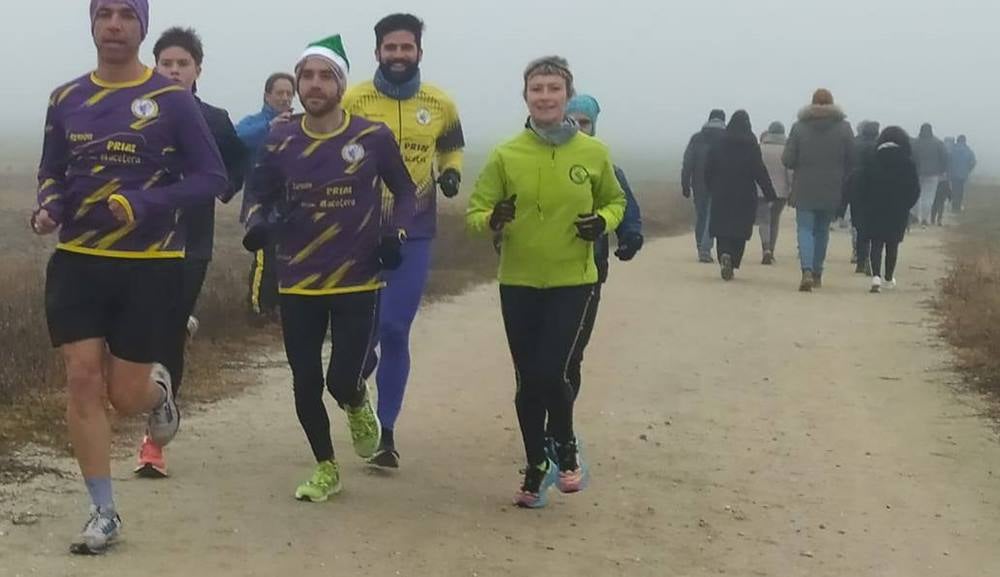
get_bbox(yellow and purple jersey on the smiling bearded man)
[343,80,465,239]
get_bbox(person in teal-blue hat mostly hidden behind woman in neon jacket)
[566,94,643,393]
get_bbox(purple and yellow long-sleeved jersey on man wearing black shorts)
[38,69,227,259]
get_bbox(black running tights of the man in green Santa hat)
[281,291,379,462]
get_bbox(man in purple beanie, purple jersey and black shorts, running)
[31,0,226,554]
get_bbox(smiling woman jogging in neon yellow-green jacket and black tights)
[466,56,625,508]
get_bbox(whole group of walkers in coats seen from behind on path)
[681,89,976,292]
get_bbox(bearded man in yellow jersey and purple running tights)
[344,14,465,468]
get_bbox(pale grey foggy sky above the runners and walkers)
[0,0,1000,177]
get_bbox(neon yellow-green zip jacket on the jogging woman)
[466,129,625,288]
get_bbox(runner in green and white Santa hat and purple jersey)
[244,36,416,502]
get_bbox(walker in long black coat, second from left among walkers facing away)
[705,110,778,280]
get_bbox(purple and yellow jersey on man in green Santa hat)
[247,113,416,296]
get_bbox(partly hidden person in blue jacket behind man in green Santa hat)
[236,72,295,318]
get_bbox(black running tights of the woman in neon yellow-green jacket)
[500,285,598,466]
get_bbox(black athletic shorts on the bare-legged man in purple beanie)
[45,250,184,363]
